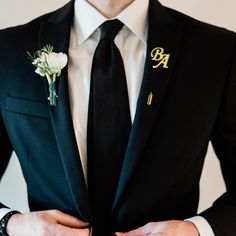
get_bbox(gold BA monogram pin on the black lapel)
[151,47,170,69]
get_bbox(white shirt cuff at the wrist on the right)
[185,216,215,236]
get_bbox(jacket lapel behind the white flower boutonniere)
[39,1,91,222]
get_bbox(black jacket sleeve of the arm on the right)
[200,35,236,236]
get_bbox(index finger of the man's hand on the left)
[48,210,88,229]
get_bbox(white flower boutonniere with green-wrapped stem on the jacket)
[27,44,68,106]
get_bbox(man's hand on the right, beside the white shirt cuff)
[116,220,199,236]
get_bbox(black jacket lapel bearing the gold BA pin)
[113,0,182,209]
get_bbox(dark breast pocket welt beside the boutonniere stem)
[6,95,50,118]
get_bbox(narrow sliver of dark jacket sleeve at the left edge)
[0,107,13,208]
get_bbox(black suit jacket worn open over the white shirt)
[0,0,236,236]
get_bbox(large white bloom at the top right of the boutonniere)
[45,52,68,70]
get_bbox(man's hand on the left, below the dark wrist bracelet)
[7,210,89,236]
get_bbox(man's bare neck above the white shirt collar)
[86,0,134,18]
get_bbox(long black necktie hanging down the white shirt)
[88,20,131,236]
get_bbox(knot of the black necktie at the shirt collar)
[100,20,123,40]
